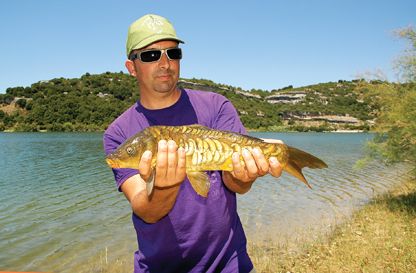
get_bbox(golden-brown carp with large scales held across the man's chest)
[106,124,328,197]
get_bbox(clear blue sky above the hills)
[0,0,416,93]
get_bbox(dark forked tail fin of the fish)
[283,146,328,188]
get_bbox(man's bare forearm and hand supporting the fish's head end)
[121,140,186,223]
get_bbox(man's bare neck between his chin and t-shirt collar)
[140,88,181,110]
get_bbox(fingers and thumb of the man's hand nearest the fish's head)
[139,140,186,189]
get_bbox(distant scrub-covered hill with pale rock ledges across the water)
[0,72,384,131]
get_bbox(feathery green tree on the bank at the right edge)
[364,28,416,175]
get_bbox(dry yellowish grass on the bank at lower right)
[248,176,416,273]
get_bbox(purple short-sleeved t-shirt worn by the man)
[104,89,253,272]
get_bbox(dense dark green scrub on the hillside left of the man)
[0,72,138,131]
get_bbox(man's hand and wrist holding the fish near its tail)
[223,139,283,193]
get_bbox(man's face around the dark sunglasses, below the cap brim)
[126,41,180,93]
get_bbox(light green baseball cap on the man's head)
[126,14,183,58]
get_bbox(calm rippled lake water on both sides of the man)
[0,133,405,272]
